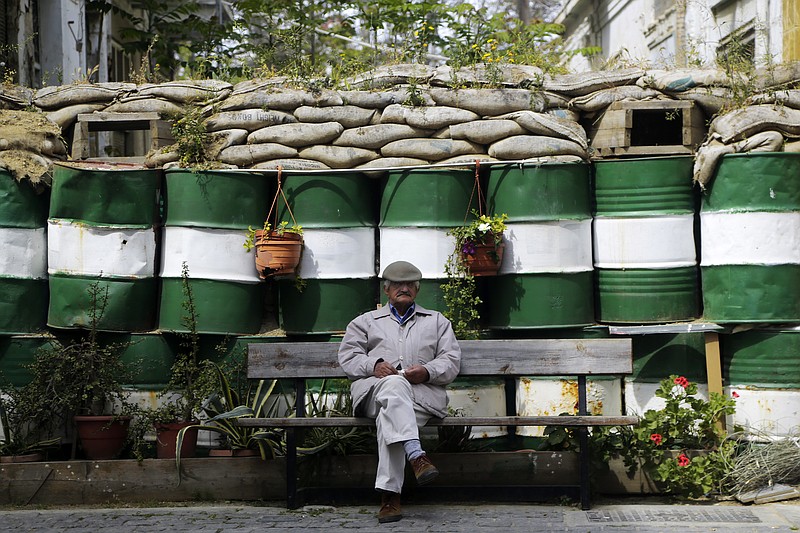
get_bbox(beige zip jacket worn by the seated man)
[339,304,461,417]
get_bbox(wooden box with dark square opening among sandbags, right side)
[588,100,707,157]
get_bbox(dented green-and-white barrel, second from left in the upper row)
[47,163,160,331]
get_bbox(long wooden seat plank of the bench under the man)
[236,415,638,428]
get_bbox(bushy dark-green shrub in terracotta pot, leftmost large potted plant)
[15,282,138,459]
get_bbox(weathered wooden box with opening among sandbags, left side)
[72,112,175,162]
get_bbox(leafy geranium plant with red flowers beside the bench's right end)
[544,375,736,498]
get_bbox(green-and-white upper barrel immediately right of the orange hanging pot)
[277,172,378,335]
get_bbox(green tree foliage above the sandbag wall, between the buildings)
[94,0,592,80]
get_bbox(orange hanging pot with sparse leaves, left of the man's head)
[244,220,303,279]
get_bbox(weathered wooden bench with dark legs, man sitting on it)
[237,338,638,509]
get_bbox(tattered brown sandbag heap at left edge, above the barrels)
[0,110,66,184]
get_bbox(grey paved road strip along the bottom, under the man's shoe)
[0,503,800,533]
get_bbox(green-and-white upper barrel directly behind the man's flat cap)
[378,169,478,311]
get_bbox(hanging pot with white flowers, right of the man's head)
[448,210,508,276]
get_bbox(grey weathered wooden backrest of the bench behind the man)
[247,338,633,379]
